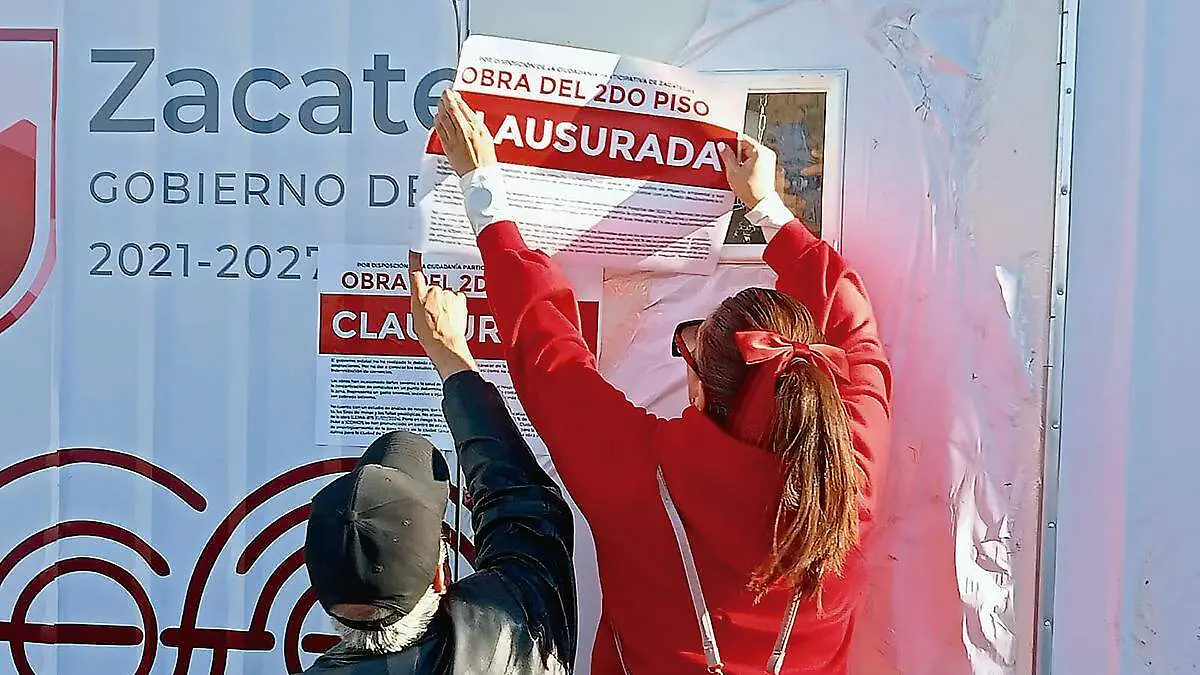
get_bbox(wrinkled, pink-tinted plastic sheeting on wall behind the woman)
[602,0,1050,675]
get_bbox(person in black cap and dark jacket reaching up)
[305,258,577,675]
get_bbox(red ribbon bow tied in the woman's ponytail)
[730,330,850,447]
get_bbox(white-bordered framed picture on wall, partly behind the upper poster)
[709,70,846,263]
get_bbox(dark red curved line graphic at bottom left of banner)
[0,448,475,675]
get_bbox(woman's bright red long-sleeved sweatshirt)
[479,220,892,675]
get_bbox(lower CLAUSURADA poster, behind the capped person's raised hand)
[316,246,600,449]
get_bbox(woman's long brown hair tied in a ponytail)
[696,288,858,602]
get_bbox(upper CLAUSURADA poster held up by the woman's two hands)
[419,36,744,273]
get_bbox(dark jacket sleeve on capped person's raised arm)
[442,371,578,663]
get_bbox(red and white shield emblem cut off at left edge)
[0,29,58,333]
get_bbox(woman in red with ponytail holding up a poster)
[437,91,892,675]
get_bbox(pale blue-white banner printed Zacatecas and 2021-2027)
[0,0,473,675]
